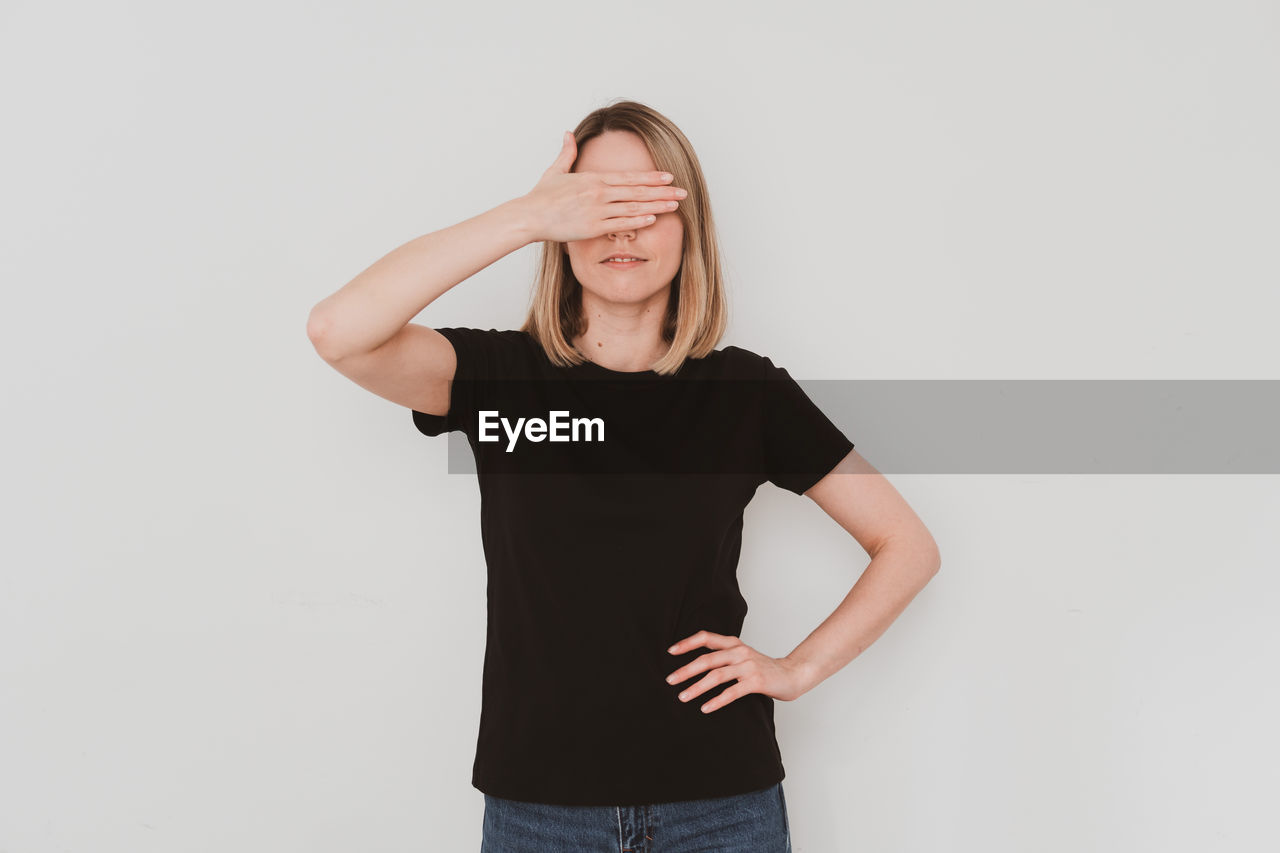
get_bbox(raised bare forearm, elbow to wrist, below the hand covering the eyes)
[307,197,532,359]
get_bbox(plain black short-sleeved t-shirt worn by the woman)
[412,328,854,806]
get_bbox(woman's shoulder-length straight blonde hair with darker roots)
[521,100,728,375]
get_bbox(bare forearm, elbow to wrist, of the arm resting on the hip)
[787,539,940,693]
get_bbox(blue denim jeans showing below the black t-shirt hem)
[480,783,791,853]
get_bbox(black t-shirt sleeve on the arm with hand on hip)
[762,357,854,494]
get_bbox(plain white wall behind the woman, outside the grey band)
[0,0,1280,853]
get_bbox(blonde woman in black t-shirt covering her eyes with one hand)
[308,101,940,853]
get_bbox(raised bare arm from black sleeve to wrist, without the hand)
[307,196,535,415]
